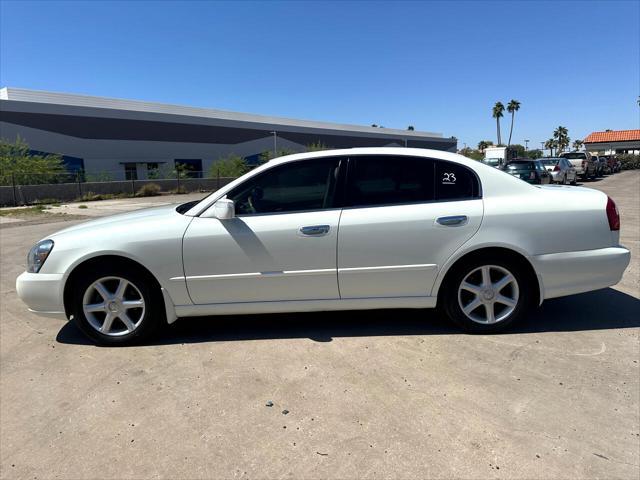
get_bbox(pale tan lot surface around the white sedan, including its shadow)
[0,172,640,479]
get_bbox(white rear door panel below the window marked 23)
[338,200,482,298]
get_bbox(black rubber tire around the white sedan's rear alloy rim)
[441,254,535,333]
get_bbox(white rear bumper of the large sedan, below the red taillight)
[532,247,631,300]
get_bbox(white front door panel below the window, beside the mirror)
[182,210,340,304]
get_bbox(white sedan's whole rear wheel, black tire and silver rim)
[443,256,532,333]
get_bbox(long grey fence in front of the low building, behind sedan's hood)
[0,170,235,206]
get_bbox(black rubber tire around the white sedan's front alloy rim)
[70,265,166,346]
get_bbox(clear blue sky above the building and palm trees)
[0,0,640,148]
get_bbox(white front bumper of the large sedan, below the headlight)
[16,272,67,319]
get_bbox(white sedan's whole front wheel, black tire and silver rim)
[71,267,164,345]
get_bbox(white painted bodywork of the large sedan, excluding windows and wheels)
[16,148,629,321]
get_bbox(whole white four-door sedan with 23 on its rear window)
[17,148,629,344]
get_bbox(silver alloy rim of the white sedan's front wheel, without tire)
[82,277,145,337]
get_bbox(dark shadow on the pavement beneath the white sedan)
[56,288,640,346]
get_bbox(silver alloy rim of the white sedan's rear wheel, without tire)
[458,265,520,324]
